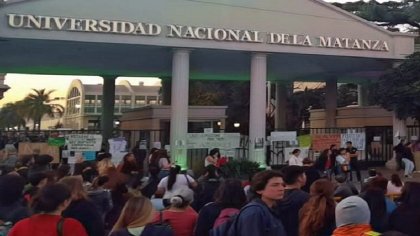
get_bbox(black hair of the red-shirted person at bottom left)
[31,184,71,213]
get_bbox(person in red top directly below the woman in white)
[154,187,198,236]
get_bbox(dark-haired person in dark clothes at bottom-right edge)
[389,182,420,236]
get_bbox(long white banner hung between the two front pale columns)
[187,133,241,149]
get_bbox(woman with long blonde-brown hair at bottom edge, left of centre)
[110,196,172,236]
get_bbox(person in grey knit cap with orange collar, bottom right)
[332,196,379,236]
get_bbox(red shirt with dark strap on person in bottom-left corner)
[8,214,87,236]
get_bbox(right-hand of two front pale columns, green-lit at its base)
[249,53,267,168]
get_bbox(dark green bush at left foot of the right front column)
[221,159,260,179]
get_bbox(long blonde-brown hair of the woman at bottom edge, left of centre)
[111,196,155,232]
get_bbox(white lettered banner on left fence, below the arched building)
[66,134,102,152]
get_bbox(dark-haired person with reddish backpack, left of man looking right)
[194,179,246,236]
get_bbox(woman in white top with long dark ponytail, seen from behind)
[156,165,197,207]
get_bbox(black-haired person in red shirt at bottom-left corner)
[8,184,88,236]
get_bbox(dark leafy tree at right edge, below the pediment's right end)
[374,52,420,121]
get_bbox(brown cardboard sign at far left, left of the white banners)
[18,143,60,163]
